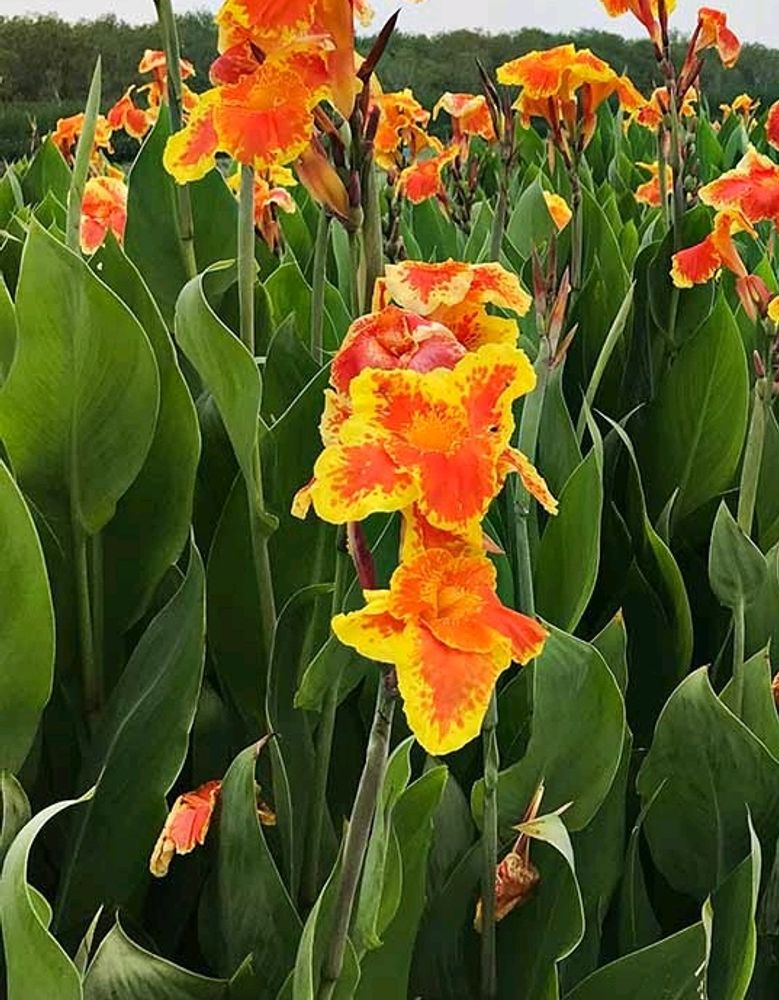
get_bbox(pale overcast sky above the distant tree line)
[0,0,779,47]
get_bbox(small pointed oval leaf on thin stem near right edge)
[709,500,768,611]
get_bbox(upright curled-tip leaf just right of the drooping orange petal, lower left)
[200,737,302,993]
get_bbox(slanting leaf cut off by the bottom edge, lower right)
[565,924,706,1000]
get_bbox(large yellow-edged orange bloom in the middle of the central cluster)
[293,344,548,538]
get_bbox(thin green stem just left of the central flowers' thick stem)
[302,544,349,907]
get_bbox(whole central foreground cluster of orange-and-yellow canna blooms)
[293,261,556,753]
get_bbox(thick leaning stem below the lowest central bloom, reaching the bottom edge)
[318,677,395,1000]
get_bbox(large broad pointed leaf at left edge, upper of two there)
[0,223,159,534]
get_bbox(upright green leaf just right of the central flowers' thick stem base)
[355,766,448,1000]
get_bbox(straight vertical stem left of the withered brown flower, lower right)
[481,691,500,1000]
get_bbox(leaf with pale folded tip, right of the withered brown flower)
[498,815,584,1000]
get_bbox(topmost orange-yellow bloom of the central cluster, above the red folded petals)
[386,260,532,351]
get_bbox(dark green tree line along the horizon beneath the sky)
[0,12,779,159]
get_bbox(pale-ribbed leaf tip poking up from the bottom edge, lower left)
[84,921,232,1000]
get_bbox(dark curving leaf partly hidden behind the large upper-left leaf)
[92,239,200,630]
